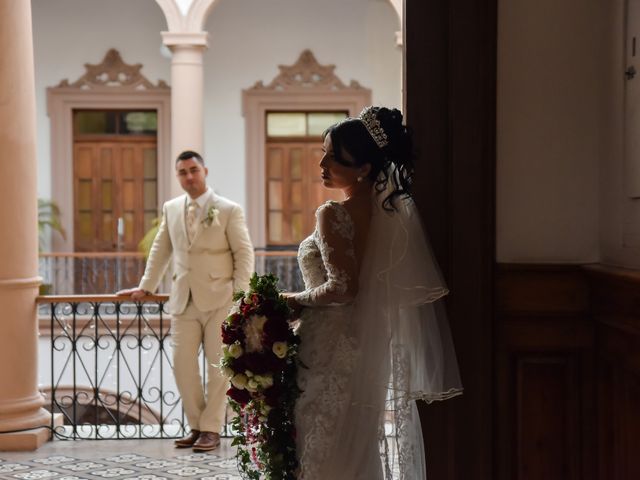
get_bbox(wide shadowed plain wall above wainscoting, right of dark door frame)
[496,0,609,263]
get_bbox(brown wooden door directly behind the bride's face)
[266,141,343,246]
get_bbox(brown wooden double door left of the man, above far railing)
[74,139,157,252]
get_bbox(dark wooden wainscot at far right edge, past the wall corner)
[586,265,640,480]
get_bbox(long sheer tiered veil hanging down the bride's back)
[322,171,462,480]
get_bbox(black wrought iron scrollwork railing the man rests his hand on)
[38,295,196,439]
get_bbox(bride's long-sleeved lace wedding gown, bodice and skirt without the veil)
[296,202,358,480]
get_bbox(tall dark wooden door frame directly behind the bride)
[403,0,500,480]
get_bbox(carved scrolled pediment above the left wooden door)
[57,48,169,90]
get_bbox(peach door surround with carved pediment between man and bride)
[242,50,371,248]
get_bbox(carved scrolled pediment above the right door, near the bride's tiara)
[251,50,364,91]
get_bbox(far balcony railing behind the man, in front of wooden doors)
[39,250,303,295]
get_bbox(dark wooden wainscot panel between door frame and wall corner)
[495,265,596,480]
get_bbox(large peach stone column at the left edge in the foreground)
[0,0,51,450]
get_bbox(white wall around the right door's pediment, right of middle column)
[204,0,402,204]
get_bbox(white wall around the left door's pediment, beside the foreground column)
[31,0,171,202]
